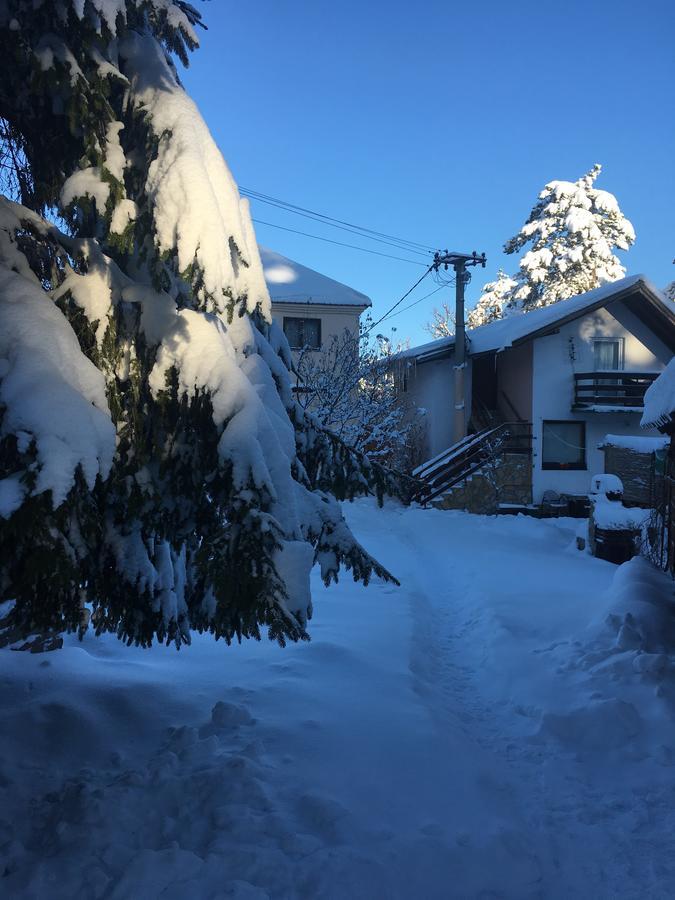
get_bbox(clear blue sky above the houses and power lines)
[183,0,675,343]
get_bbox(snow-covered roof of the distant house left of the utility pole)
[258,247,372,309]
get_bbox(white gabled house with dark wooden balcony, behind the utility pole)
[401,275,675,503]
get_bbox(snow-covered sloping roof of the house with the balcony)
[401,275,675,363]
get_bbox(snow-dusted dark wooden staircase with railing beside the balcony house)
[413,422,532,506]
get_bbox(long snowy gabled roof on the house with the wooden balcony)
[401,275,675,362]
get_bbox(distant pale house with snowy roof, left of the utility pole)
[259,247,371,358]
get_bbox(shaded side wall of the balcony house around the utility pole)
[403,356,471,459]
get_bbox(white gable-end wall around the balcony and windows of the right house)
[532,304,671,503]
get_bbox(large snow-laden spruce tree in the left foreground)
[0,0,402,645]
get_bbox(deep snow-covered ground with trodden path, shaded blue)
[0,501,675,900]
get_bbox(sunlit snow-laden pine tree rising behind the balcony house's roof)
[504,164,635,311]
